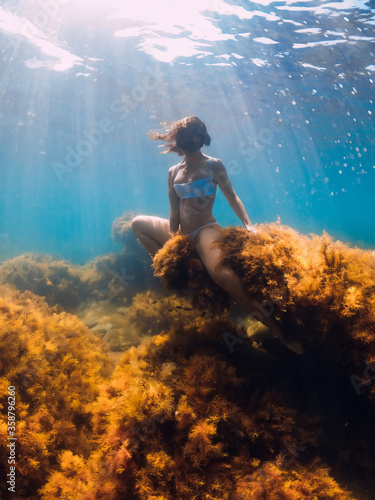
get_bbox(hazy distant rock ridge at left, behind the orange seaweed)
[0,252,157,313]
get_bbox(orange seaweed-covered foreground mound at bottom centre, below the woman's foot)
[40,319,356,500]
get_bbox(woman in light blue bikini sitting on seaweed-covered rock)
[132,116,298,350]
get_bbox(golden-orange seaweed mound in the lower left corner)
[0,287,112,498]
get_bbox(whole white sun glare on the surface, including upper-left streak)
[0,0,247,68]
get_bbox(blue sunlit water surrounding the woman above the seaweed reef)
[0,0,375,262]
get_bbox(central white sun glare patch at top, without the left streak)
[62,0,241,63]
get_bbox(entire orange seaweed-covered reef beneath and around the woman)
[0,225,375,500]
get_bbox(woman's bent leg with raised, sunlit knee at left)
[132,215,171,257]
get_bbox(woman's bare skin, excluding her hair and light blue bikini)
[132,150,301,353]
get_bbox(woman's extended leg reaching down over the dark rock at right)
[197,227,302,354]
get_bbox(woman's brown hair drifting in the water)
[148,116,211,156]
